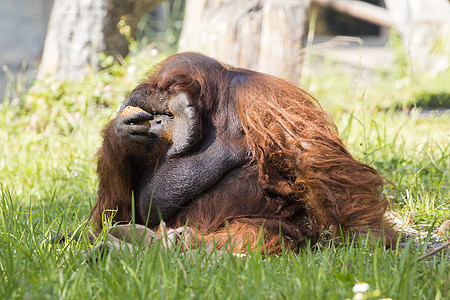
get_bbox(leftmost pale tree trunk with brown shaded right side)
[38,0,162,80]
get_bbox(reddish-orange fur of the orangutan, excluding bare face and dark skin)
[93,54,392,253]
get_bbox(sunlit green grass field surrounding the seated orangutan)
[0,49,450,299]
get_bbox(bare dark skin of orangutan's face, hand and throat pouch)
[112,91,250,227]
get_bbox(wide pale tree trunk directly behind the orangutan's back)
[178,0,310,83]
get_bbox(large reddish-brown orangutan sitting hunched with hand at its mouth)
[91,53,387,251]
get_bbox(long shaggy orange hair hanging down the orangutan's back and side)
[236,72,388,236]
